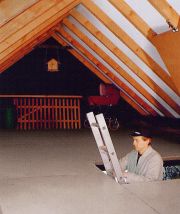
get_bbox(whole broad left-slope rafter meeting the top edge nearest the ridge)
[0,0,79,72]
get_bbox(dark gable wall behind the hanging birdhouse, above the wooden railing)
[0,39,101,96]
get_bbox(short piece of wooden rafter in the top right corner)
[148,0,179,28]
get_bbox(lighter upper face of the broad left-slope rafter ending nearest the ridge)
[0,0,79,53]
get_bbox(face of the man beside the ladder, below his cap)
[133,136,150,154]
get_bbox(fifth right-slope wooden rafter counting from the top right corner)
[63,18,173,117]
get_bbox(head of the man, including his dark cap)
[131,130,152,154]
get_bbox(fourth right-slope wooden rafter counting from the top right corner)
[70,9,180,113]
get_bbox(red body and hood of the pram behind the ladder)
[88,83,120,105]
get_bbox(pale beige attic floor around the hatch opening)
[0,129,180,214]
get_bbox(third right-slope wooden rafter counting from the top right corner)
[82,0,177,92]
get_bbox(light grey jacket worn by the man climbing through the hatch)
[120,146,163,183]
